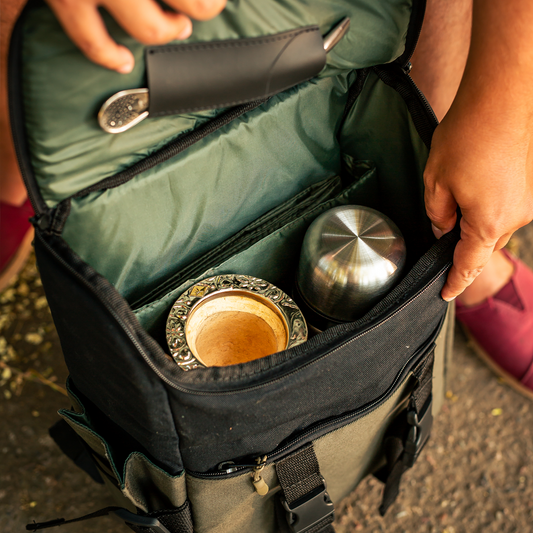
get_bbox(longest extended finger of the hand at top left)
[48,0,134,74]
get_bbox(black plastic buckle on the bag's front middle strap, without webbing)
[281,478,335,533]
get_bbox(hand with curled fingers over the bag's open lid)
[46,0,226,74]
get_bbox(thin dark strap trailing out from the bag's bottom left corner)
[26,500,193,533]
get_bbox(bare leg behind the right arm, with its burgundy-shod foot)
[411,0,533,399]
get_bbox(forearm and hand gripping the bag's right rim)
[424,0,533,300]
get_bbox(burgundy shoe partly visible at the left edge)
[0,199,33,292]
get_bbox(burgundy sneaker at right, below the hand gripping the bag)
[457,250,533,400]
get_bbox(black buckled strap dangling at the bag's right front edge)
[377,348,435,516]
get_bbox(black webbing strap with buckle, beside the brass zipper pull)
[276,444,335,533]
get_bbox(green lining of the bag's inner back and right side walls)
[60,67,431,324]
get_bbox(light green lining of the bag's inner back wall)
[63,75,354,302]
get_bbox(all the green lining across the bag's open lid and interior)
[19,0,432,354]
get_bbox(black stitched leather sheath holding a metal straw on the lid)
[146,26,326,116]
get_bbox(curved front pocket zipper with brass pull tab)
[190,317,438,480]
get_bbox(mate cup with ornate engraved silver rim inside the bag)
[166,274,307,370]
